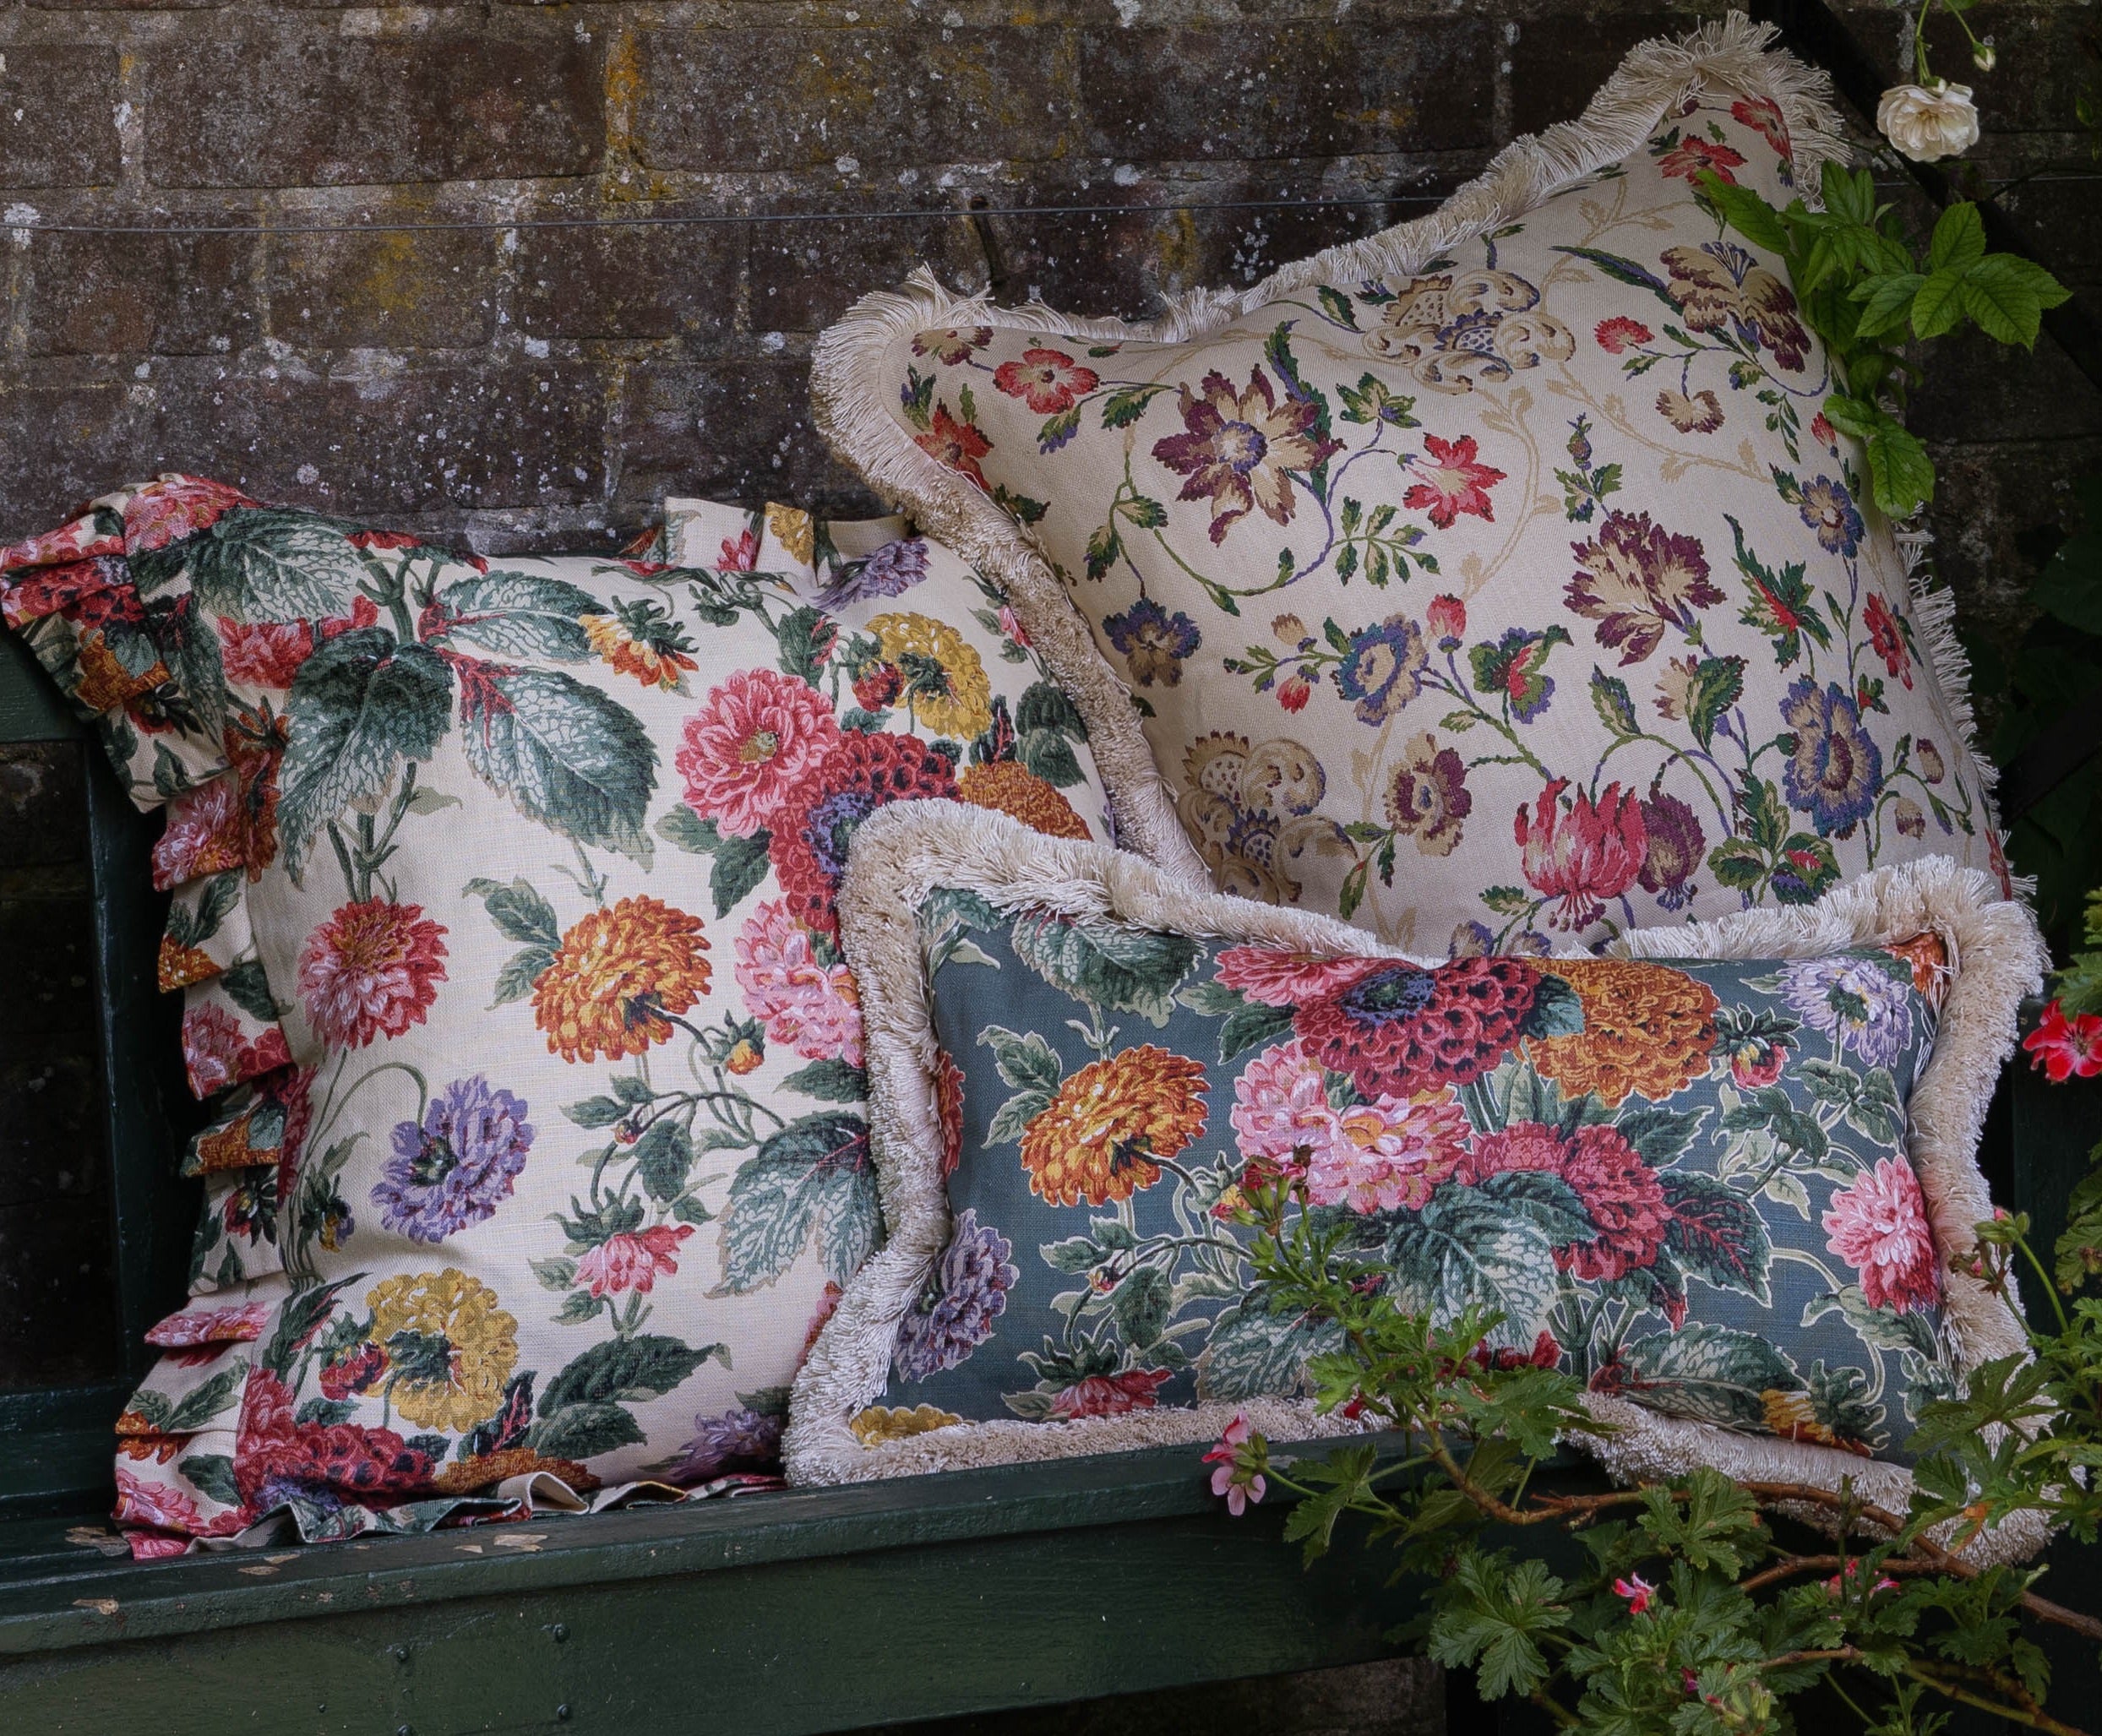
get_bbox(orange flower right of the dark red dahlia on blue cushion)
[1526,958,1718,1106]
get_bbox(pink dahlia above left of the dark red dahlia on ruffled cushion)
[677,668,839,839]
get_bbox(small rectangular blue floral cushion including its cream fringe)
[788,803,2039,1547]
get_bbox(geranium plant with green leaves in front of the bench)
[1206,1167,2102,1736]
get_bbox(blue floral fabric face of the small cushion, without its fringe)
[882,895,1952,1452]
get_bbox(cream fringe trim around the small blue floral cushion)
[784,801,2045,1562]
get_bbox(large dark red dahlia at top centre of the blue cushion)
[1293,958,1538,1097]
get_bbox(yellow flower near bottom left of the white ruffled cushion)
[366,1265,520,1434]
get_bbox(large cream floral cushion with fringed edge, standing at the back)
[818,19,2006,952]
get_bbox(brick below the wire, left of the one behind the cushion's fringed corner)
[520,223,746,339]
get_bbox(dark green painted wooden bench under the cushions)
[0,634,2102,1736]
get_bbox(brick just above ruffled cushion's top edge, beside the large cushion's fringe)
[618,357,876,513]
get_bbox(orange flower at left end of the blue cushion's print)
[1021,1044,1206,1206]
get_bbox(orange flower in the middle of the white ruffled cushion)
[531,897,711,1061]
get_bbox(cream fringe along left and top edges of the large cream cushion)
[811,13,1845,884]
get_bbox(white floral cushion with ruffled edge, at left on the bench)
[0,475,1135,1554]
